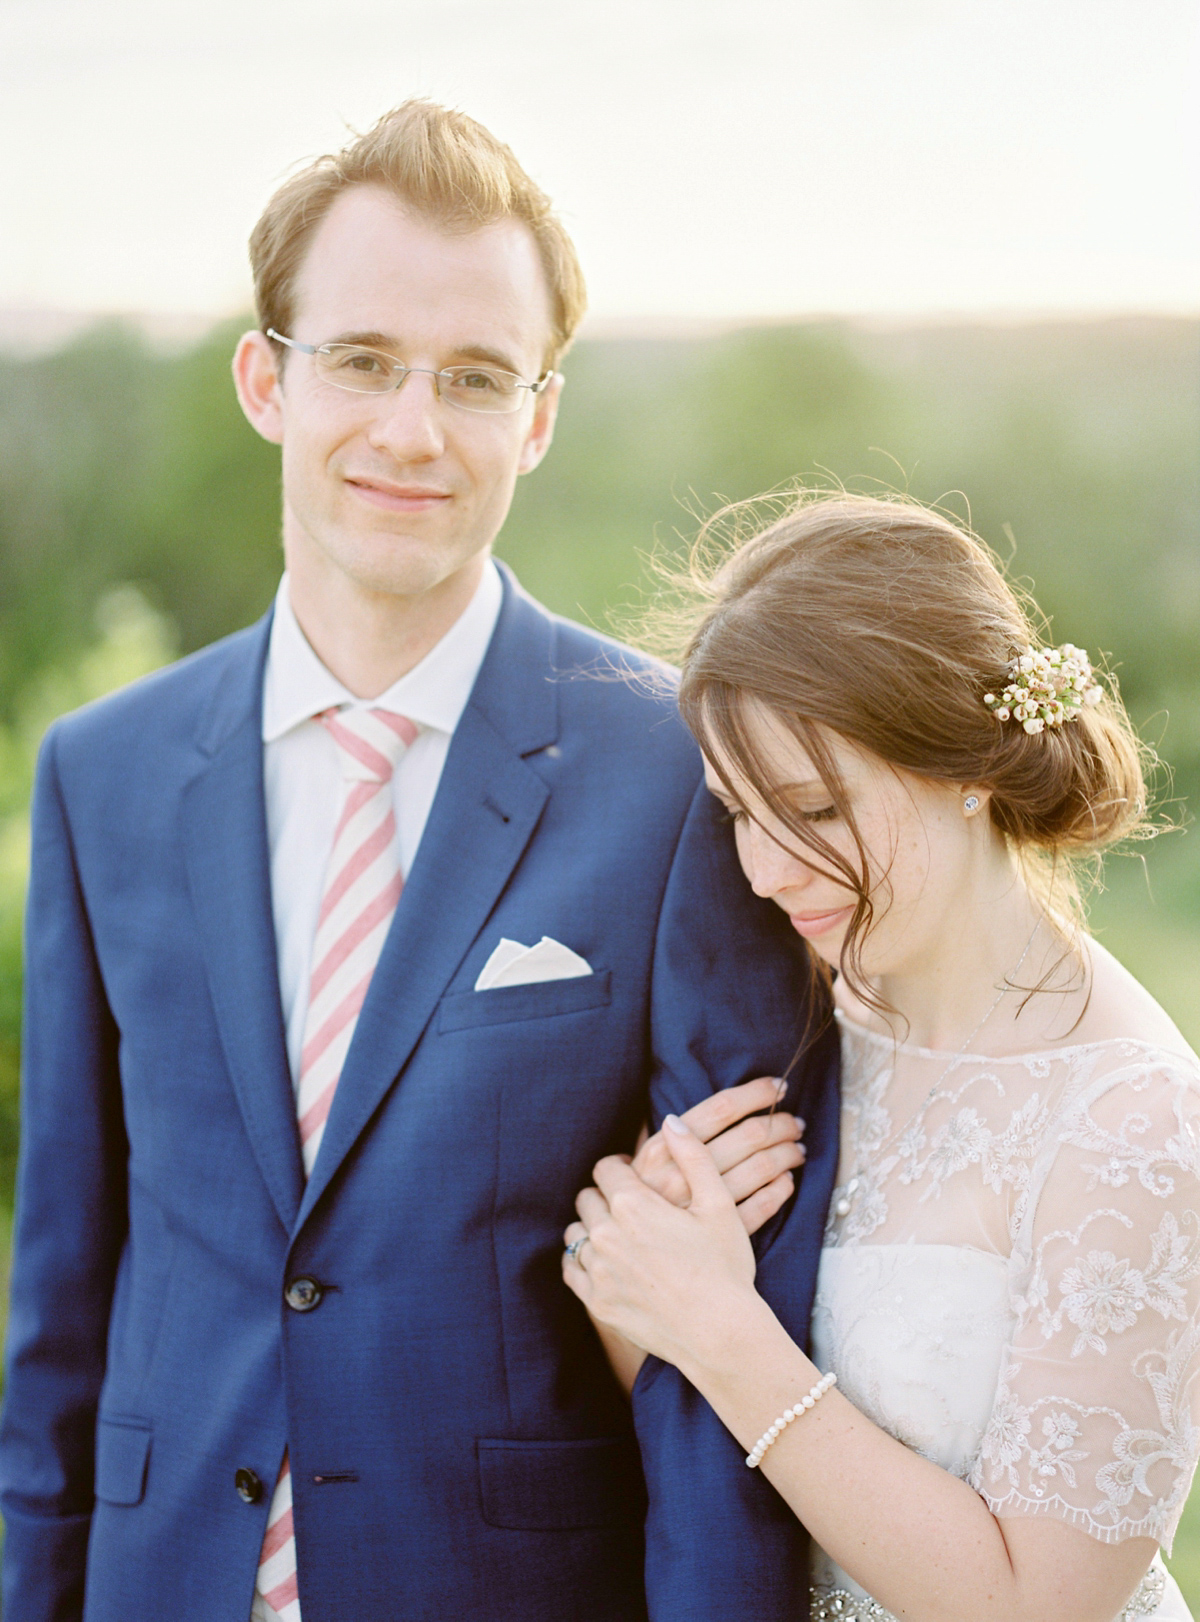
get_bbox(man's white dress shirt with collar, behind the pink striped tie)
[263,561,503,1080]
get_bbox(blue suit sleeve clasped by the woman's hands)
[632,772,838,1622]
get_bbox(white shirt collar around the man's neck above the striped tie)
[263,560,504,743]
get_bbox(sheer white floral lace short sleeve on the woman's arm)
[971,1051,1200,1552]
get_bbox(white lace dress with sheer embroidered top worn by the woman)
[812,1017,1200,1622]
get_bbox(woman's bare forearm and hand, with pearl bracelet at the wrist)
[564,1122,1156,1622]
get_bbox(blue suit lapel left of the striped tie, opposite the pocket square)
[183,618,303,1233]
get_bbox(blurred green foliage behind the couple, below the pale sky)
[0,320,1200,1590]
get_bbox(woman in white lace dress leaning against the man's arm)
[563,495,1200,1622]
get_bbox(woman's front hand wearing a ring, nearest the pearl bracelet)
[563,1115,758,1371]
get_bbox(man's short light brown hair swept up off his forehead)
[250,99,587,367]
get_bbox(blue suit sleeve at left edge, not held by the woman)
[0,728,128,1622]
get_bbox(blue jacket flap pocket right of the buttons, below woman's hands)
[477,1437,645,1531]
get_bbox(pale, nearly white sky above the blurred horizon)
[0,0,1200,323]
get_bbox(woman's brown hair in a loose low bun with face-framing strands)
[649,490,1148,1002]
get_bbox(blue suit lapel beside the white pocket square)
[300,571,558,1221]
